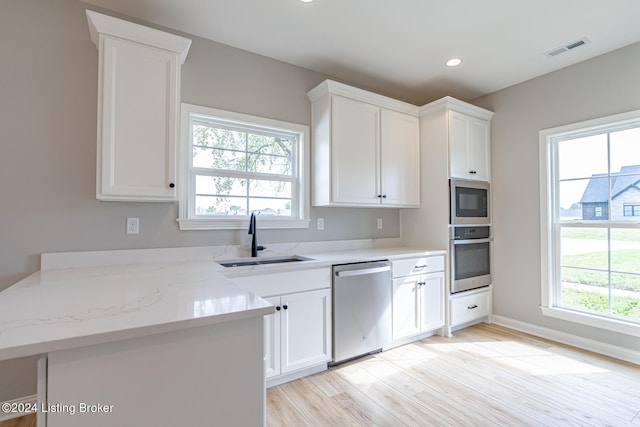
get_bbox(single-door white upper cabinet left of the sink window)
[87,10,191,202]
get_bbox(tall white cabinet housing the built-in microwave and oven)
[400,97,493,334]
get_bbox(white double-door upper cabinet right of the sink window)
[308,80,420,207]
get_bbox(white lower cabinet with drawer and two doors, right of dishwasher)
[392,256,445,343]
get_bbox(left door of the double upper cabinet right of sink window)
[331,95,380,205]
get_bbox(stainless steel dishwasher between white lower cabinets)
[331,260,391,364]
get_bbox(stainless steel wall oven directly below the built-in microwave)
[450,226,492,294]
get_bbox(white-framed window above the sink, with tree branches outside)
[178,104,309,230]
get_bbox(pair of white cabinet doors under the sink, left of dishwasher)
[264,289,331,379]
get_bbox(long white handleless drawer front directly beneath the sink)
[229,268,331,297]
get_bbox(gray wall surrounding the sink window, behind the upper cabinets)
[0,0,400,401]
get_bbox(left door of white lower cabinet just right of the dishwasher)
[392,276,422,340]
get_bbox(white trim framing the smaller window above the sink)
[177,102,310,230]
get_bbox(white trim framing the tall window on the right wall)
[538,110,640,337]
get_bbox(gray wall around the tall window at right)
[473,43,640,351]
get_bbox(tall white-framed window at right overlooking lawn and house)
[540,111,640,336]
